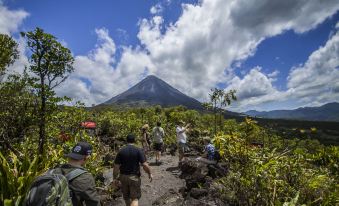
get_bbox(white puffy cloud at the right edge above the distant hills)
[287,31,339,103]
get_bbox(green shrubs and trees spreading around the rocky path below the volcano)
[0,29,339,206]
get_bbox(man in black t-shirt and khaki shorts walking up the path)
[113,134,153,206]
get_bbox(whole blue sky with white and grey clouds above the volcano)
[0,0,339,111]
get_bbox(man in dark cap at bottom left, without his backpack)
[59,142,100,206]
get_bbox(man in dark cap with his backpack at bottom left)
[25,142,100,206]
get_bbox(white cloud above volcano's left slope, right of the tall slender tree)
[56,28,152,105]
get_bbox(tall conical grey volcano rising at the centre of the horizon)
[99,75,203,110]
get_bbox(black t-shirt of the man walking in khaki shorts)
[114,144,146,176]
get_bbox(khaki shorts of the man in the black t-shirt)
[119,174,141,200]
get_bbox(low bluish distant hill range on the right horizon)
[245,102,339,122]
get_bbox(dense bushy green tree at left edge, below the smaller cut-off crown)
[0,73,36,156]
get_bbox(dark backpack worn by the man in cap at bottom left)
[24,168,87,206]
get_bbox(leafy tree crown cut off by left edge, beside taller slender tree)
[0,34,19,80]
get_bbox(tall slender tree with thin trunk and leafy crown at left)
[21,28,74,155]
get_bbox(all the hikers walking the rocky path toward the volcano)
[25,121,215,206]
